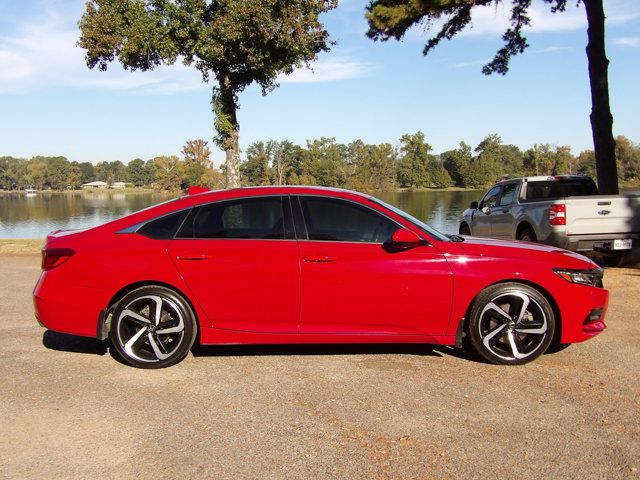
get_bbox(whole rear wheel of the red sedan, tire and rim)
[109,286,197,368]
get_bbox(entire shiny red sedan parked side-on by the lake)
[34,187,608,368]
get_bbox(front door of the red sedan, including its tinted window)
[292,196,452,335]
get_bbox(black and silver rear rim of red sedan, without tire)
[116,295,185,363]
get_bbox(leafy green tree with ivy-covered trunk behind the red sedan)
[79,0,336,187]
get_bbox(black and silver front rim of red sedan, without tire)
[478,291,549,360]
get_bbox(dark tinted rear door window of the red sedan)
[178,197,285,239]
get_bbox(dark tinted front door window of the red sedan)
[300,197,399,243]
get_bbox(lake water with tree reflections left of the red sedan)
[0,192,168,238]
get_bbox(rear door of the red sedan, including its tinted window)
[168,196,300,333]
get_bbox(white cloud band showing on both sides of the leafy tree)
[0,2,369,94]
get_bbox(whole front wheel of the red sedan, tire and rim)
[467,283,555,365]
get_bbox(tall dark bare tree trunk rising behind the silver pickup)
[582,0,618,195]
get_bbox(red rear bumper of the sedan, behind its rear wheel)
[33,272,106,338]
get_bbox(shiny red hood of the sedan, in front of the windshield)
[459,236,598,268]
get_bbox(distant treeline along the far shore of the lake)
[0,132,640,190]
